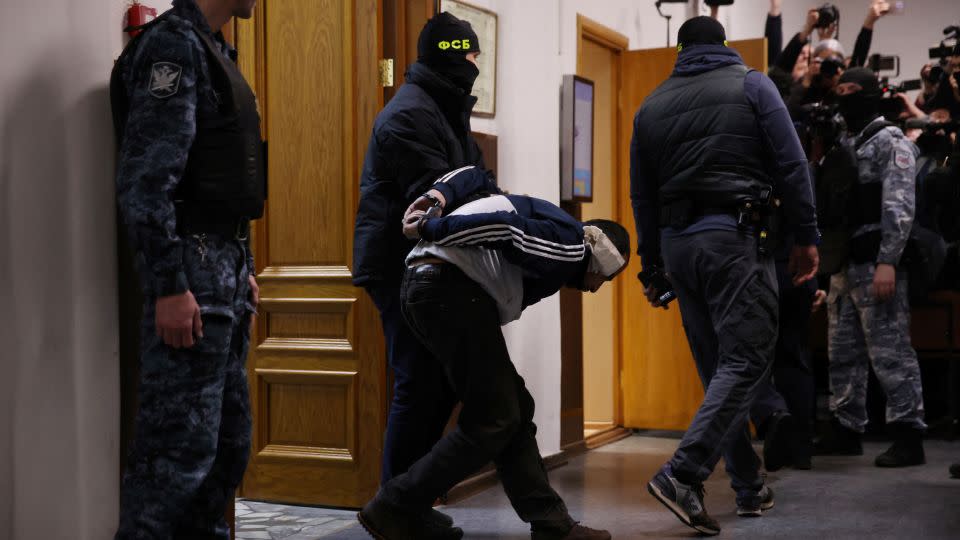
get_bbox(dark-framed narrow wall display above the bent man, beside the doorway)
[560,75,594,202]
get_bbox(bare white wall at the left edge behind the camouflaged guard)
[0,0,148,540]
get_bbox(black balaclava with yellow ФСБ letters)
[417,12,480,94]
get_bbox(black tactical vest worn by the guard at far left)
[110,18,267,223]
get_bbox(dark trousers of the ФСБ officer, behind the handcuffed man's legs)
[368,287,456,484]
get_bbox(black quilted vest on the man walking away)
[637,65,772,207]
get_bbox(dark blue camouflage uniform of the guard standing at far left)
[116,0,254,539]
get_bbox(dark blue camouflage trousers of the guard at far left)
[116,236,254,540]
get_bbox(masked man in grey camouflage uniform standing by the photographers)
[815,68,926,467]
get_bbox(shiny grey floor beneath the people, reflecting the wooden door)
[238,436,960,540]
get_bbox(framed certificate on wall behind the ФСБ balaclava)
[440,0,497,118]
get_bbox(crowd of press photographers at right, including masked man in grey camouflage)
[707,0,960,477]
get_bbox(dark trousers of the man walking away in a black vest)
[663,231,777,491]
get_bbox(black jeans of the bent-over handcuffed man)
[383,264,573,529]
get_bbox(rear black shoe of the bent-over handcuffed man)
[357,494,463,540]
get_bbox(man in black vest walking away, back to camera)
[630,17,818,535]
